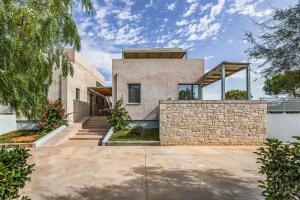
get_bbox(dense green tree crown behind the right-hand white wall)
[263,70,300,97]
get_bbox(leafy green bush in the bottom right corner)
[256,137,300,200]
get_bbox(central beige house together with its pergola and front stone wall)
[112,48,267,145]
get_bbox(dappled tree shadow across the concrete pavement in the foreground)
[42,167,263,200]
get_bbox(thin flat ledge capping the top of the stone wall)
[159,100,267,104]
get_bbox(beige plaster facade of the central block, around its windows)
[112,58,204,120]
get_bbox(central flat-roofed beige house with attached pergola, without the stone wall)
[112,48,250,121]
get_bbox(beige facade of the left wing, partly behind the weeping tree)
[48,49,105,122]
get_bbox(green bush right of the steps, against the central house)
[107,99,131,132]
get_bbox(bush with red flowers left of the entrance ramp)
[38,100,68,132]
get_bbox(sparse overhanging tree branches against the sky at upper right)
[246,1,300,78]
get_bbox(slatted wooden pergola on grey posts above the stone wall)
[199,61,251,100]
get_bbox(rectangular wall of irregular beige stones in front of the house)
[159,100,267,145]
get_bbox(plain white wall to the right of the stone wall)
[268,113,300,142]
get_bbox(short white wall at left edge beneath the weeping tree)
[0,114,17,135]
